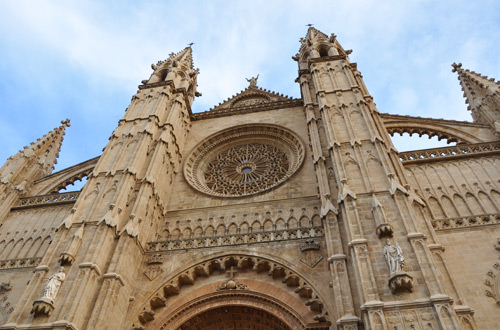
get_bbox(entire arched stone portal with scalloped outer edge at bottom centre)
[129,254,331,330]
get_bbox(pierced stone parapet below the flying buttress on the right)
[399,142,500,164]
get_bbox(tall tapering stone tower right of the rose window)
[294,27,472,329]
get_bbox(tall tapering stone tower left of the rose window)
[6,47,198,329]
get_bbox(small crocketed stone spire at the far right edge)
[452,63,500,133]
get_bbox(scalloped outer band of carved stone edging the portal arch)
[132,255,328,330]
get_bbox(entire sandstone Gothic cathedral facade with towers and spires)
[0,27,500,330]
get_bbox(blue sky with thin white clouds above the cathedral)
[0,0,500,177]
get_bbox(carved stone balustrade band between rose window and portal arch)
[146,227,323,252]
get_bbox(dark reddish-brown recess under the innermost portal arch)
[177,306,291,330]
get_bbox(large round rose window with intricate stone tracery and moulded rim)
[184,125,304,197]
